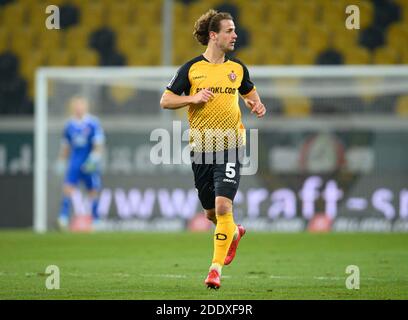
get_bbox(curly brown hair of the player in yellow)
[193,9,233,46]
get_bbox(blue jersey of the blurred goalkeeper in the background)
[63,115,105,170]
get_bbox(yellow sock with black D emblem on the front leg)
[212,212,237,266]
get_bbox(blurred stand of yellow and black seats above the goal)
[0,0,408,114]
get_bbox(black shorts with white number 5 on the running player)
[191,149,243,210]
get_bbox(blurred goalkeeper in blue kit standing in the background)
[58,96,105,230]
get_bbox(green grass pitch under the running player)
[0,231,408,300]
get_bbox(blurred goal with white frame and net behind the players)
[34,66,408,232]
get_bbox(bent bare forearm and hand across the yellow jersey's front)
[160,89,214,109]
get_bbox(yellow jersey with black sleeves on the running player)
[166,55,256,152]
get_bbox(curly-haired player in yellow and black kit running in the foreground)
[160,10,266,289]
